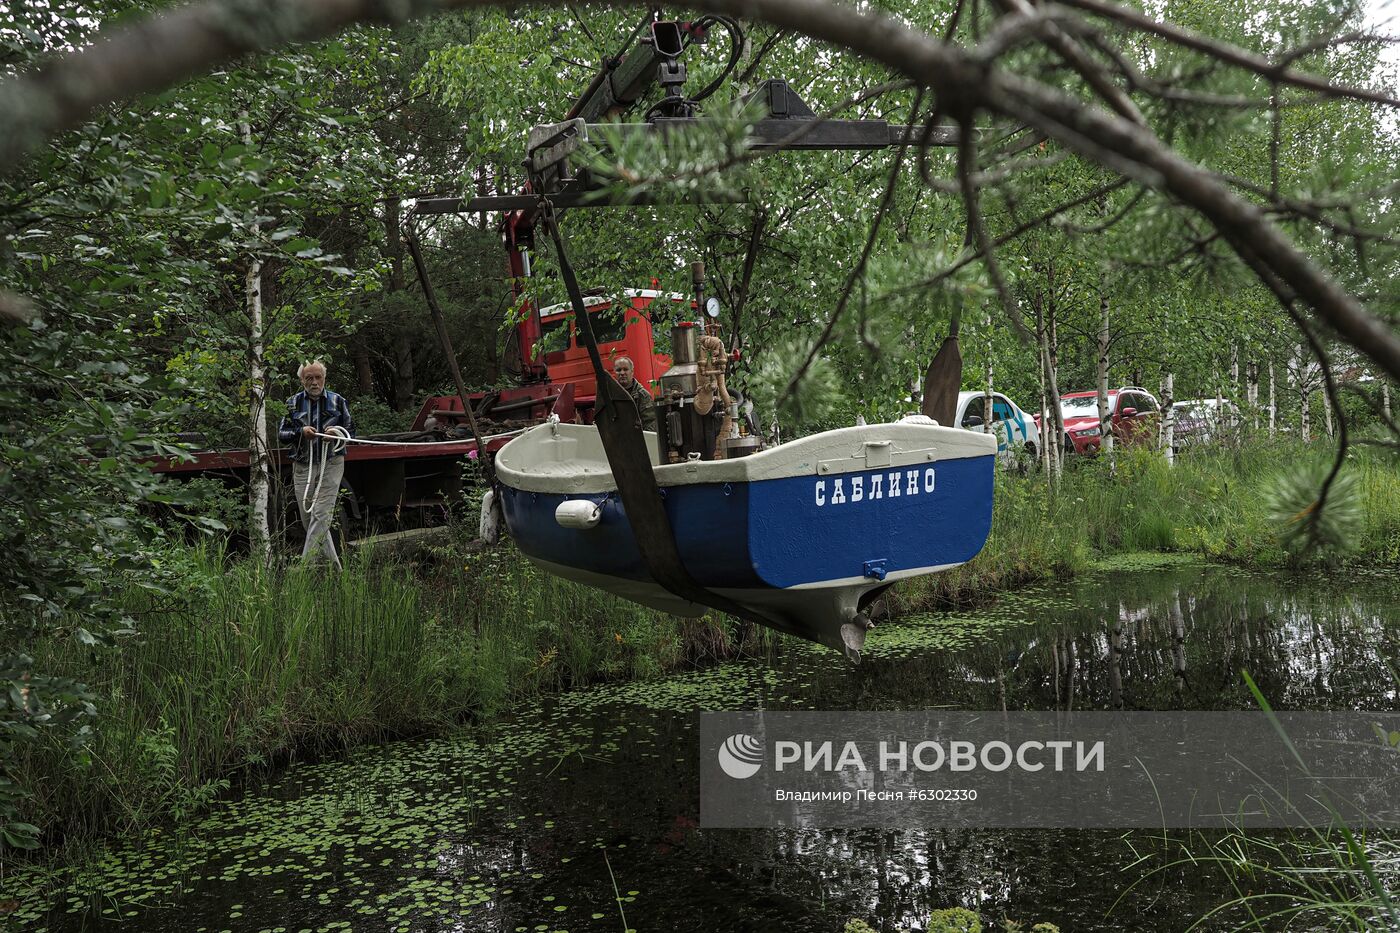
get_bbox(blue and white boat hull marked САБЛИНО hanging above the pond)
[496,416,997,653]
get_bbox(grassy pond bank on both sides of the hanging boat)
[5,437,1400,842]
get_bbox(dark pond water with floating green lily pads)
[25,554,1400,933]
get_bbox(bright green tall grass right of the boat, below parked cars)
[896,441,1400,608]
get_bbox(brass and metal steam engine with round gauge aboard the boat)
[657,262,763,464]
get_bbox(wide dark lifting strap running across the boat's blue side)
[540,199,788,629]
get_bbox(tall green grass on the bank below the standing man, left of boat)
[15,537,756,843]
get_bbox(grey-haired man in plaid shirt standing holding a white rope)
[277,360,354,570]
